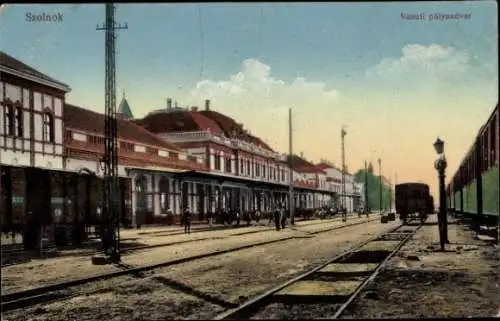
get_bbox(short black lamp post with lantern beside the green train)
[434,137,449,251]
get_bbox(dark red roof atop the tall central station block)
[134,110,224,135]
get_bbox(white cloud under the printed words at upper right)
[366,44,486,84]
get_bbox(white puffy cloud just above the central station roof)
[191,59,339,109]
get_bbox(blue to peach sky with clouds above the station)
[0,1,498,199]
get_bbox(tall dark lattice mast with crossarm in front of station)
[92,3,128,264]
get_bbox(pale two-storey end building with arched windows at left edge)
[0,52,70,244]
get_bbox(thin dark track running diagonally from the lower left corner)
[1,217,379,311]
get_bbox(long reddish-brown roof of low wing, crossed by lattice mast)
[64,104,181,151]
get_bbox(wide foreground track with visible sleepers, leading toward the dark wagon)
[214,221,422,320]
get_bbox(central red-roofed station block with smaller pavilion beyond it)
[135,99,332,217]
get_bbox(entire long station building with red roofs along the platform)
[0,52,359,248]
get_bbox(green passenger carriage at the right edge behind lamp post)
[447,105,500,224]
